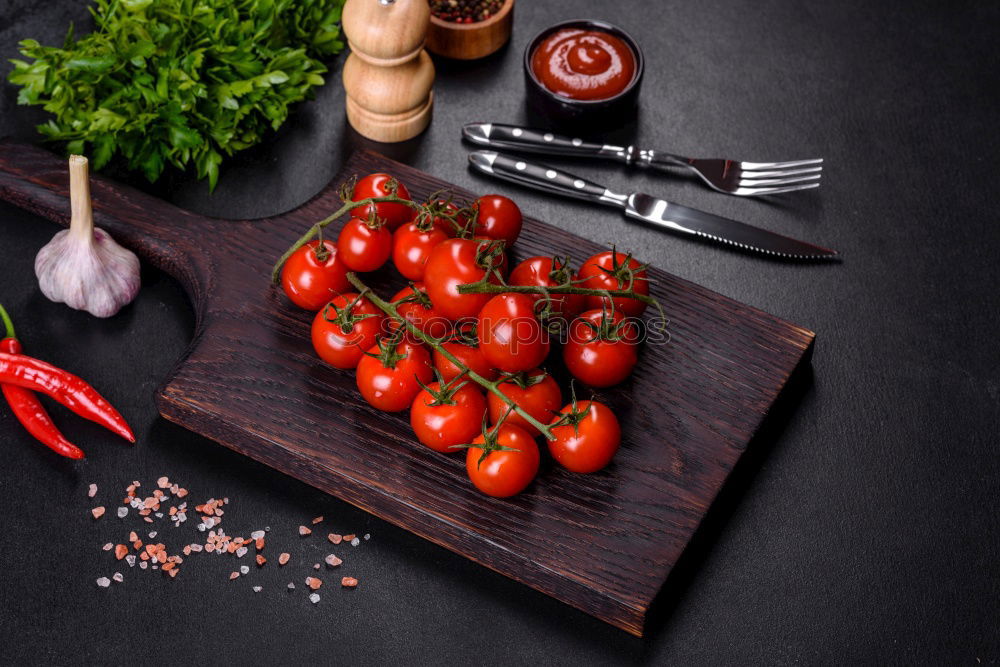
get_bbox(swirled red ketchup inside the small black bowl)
[531,28,635,100]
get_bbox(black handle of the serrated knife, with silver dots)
[469,151,626,208]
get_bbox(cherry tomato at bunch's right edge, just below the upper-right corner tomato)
[563,309,639,387]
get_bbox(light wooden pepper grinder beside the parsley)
[342,0,434,142]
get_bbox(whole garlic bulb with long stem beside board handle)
[35,155,139,317]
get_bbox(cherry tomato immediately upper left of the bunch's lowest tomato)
[410,380,486,454]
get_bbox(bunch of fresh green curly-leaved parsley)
[8,0,344,189]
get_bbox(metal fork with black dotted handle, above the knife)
[462,123,823,197]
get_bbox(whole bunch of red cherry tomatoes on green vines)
[281,173,649,497]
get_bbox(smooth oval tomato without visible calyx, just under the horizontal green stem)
[476,294,549,373]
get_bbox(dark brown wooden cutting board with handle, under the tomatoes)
[0,143,814,635]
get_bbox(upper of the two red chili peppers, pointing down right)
[0,336,135,442]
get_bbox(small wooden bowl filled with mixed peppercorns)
[426,0,514,60]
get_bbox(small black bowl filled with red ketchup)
[524,19,643,129]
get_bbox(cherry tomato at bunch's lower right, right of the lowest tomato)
[548,401,622,473]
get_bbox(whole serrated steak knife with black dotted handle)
[469,151,837,260]
